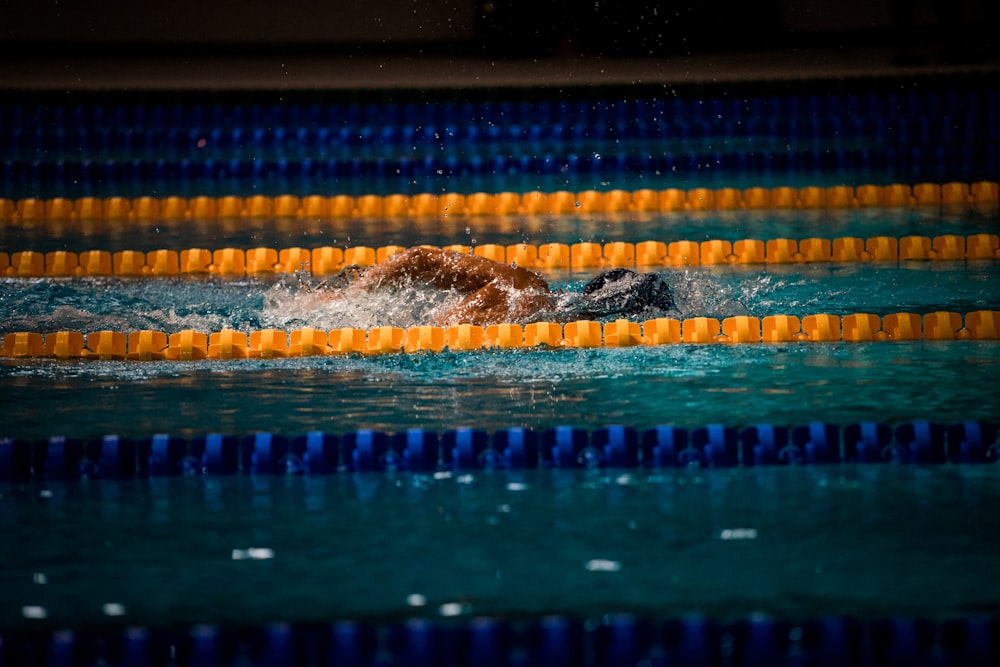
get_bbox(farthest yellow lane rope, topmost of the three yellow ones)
[0,181,1000,225]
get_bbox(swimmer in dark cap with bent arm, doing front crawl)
[324,247,674,326]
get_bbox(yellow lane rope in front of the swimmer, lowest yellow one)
[0,310,1000,361]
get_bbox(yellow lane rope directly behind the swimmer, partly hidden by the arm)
[0,233,1000,278]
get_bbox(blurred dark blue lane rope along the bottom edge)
[0,613,1000,667]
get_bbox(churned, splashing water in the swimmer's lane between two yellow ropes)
[0,265,984,334]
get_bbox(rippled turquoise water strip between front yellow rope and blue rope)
[0,341,1000,439]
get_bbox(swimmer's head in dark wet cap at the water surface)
[583,269,674,318]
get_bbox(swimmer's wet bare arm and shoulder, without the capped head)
[352,247,552,325]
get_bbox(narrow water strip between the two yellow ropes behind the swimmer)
[0,207,1000,252]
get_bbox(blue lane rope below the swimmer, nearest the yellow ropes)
[0,421,1000,482]
